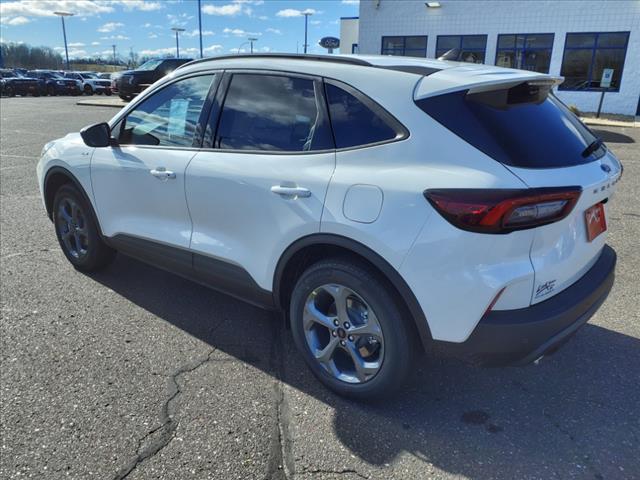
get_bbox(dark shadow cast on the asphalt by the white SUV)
[91,255,640,479]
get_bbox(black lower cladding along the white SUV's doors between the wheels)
[106,235,274,309]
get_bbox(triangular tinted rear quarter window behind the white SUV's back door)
[325,83,406,148]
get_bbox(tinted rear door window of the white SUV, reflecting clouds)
[214,73,333,152]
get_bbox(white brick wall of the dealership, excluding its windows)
[360,0,640,115]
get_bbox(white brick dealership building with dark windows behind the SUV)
[340,0,640,115]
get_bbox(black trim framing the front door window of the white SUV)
[110,70,224,151]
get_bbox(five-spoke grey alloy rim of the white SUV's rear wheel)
[303,284,384,383]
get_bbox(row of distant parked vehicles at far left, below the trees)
[0,69,112,97]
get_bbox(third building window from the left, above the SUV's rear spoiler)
[496,33,553,73]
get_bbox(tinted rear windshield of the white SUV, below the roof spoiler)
[416,89,605,168]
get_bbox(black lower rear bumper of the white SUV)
[453,245,616,366]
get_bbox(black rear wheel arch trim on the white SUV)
[273,233,432,349]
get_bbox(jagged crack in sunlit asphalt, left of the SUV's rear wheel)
[113,348,216,480]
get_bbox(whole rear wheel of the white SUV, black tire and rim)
[290,259,416,401]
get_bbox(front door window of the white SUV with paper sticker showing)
[118,75,214,147]
